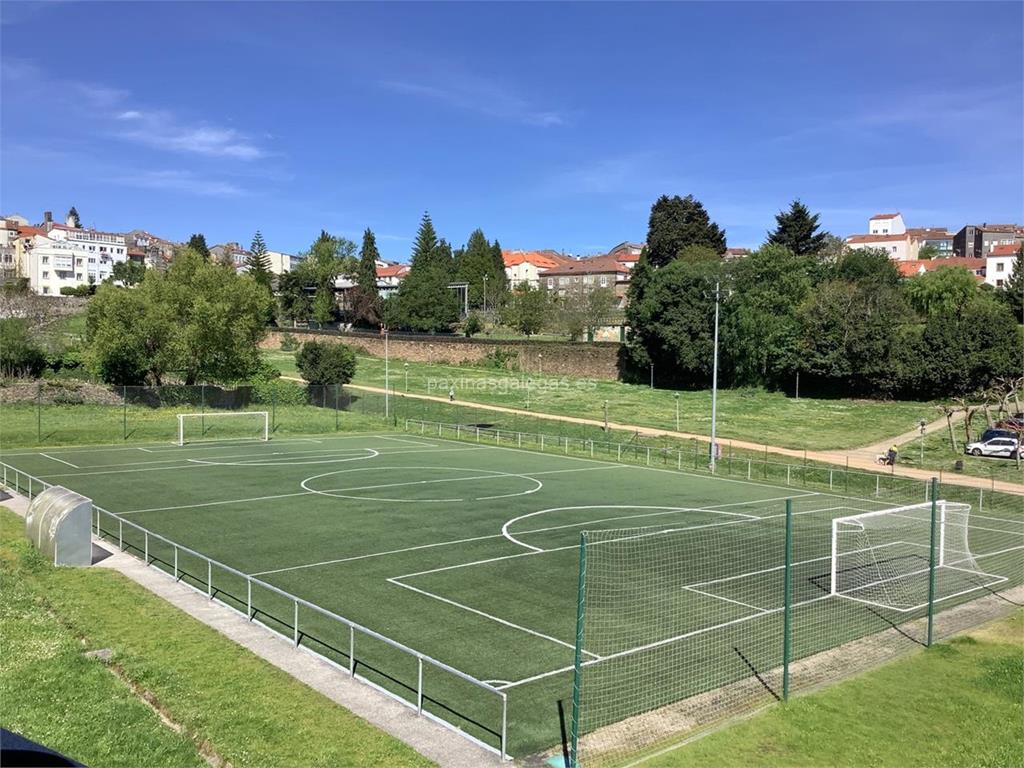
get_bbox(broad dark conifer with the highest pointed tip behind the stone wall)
[386,213,459,332]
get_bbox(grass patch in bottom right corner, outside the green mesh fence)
[644,611,1024,768]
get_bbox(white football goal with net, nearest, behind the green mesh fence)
[831,501,1006,612]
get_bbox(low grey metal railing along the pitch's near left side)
[0,462,508,761]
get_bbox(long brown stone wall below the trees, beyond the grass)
[262,330,620,380]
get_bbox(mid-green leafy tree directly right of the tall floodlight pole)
[722,245,813,386]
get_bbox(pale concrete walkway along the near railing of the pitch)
[3,494,501,768]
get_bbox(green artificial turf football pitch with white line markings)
[2,432,1024,756]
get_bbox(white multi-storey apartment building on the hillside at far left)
[17,227,128,296]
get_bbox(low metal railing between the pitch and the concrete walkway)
[0,462,508,761]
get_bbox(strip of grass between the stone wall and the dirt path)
[266,351,937,450]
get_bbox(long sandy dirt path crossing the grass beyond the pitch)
[290,376,1024,496]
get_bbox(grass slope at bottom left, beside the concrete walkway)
[0,508,430,768]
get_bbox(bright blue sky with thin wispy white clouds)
[0,2,1024,260]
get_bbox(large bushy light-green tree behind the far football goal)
[86,249,270,385]
